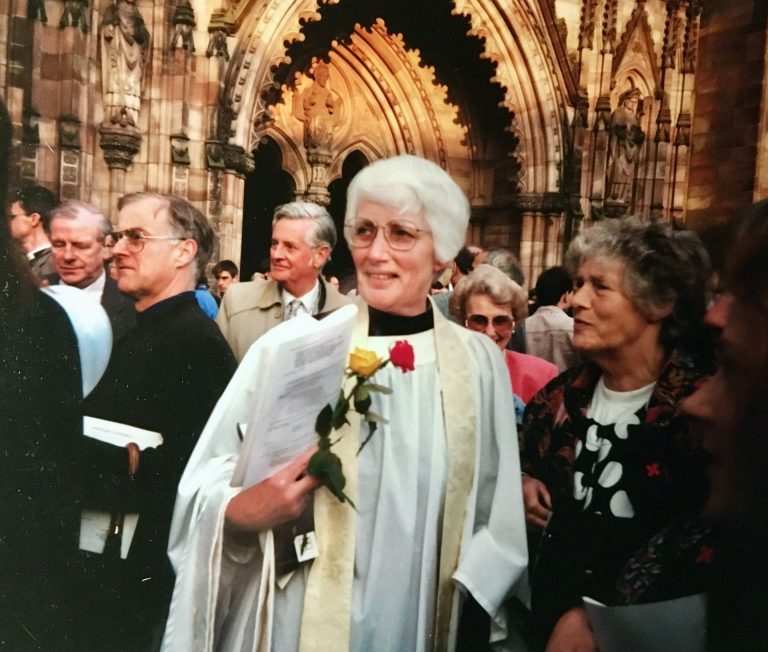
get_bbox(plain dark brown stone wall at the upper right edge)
[687,0,768,228]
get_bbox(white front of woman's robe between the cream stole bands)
[350,331,447,652]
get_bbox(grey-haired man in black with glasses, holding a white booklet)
[80,193,236,650]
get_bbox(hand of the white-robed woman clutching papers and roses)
[226,446,319,534]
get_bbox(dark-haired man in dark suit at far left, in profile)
[7,185,59,285]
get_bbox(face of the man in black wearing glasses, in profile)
[113,197,183,310]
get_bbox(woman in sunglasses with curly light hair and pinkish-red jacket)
[450,265,559,424]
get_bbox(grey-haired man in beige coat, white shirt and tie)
[216,202,350,361]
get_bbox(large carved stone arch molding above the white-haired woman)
[209,0,575,206]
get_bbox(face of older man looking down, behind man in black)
[51,210,104,288]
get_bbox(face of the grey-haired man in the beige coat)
[269,219,330,297]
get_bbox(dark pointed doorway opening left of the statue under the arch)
[240,138,296,281]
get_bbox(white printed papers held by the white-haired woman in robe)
[232,305,357,487]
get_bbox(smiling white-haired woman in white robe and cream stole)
[164,156,527,652]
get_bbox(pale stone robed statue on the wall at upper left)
[101,0,149,127]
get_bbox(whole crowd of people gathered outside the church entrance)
[0,93,768,652]
